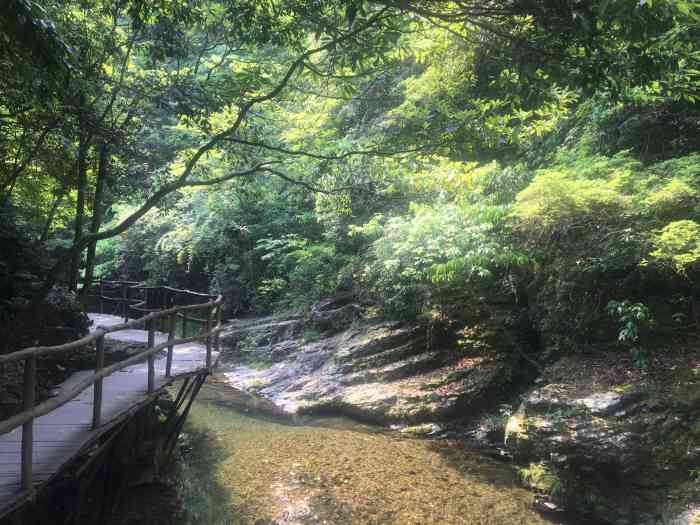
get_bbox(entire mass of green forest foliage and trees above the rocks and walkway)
[0,0,700,356]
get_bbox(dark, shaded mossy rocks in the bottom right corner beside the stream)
[505,349,700,525]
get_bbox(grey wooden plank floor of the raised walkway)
[0,314,218,516]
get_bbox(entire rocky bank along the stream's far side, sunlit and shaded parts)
[223,301,700,525]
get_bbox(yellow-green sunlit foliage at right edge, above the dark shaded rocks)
[512,143,700,282]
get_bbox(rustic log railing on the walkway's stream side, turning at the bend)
[0,283,223,491]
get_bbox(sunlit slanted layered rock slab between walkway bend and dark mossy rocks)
[222,301,512,425]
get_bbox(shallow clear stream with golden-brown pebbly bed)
[175,381,592,525]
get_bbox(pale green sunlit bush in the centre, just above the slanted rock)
[362,194,527,317]
